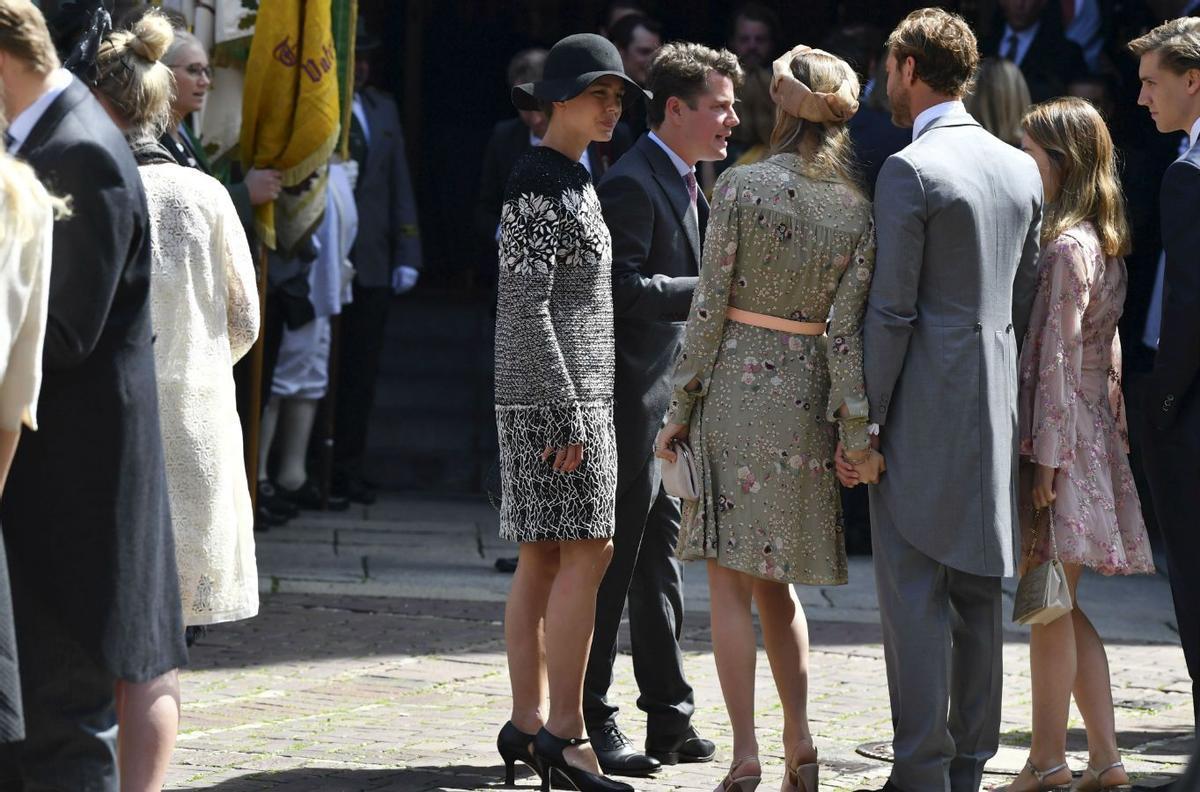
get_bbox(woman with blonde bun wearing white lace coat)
[92,14,259,790]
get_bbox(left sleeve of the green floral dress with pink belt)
[667,168,738,424]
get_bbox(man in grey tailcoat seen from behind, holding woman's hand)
[839,8,1042,792]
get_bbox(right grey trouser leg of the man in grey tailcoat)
[947,569,1004,792]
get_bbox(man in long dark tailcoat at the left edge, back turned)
[0,0,187,792]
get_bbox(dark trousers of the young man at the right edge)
[1142,395,1200,724]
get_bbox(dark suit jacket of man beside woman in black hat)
[598,134,708,498]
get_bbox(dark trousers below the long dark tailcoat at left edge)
[0,582,118,792]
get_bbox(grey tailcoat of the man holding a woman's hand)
[863,110,1042,576]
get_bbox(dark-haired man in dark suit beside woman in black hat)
[583,43,742,775]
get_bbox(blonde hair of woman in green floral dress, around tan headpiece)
[770,49,859,188]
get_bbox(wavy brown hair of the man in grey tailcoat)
[888,8,979,97]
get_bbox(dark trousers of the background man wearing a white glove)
[334,283,391,478]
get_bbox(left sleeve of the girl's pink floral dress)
[1021,235,1090,468]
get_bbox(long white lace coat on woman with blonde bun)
[139,164,259,625]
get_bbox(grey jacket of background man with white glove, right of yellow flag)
[353,88,421,288]
